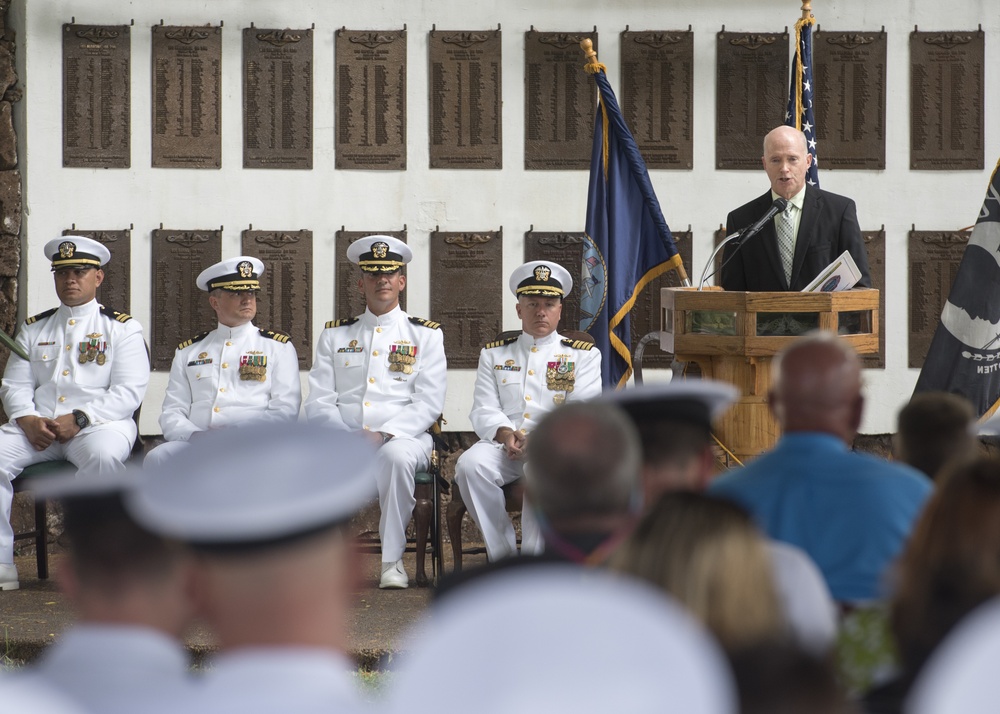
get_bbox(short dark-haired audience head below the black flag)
[893,392,978,479]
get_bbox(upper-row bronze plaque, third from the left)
[243,25,313,169]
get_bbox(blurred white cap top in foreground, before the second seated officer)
[126,422,376,549]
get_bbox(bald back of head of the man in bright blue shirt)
[768,332,864,443]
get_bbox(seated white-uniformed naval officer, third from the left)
[305,235,447,589]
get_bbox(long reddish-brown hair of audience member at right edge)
[891,458,1000,675]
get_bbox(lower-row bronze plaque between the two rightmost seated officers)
[430,229,504,369]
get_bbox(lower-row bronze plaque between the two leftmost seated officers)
[151,228,222,370]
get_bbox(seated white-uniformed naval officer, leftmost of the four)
[0,236,149,590]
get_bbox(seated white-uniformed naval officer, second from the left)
[146,255,302,464]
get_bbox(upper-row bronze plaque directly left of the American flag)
[715,29,788,171]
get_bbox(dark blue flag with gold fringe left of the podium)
[580,64,687,389]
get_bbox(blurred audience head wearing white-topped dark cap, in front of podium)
[604,379,739,506]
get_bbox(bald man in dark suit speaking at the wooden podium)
[722,126,871,291]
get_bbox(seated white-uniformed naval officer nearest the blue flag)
[455,260,601,561]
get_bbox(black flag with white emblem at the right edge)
[914,163,1000,417]
